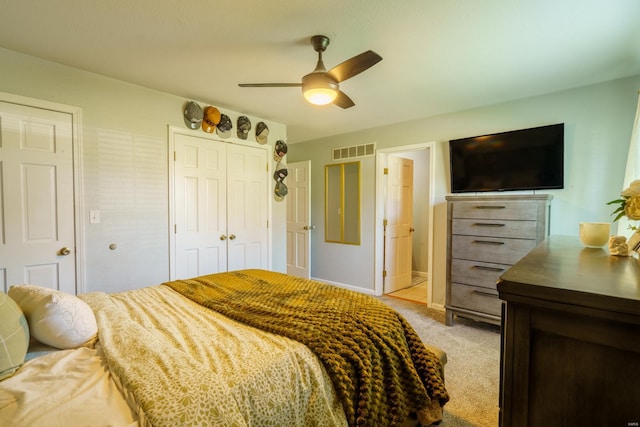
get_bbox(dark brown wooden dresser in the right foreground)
[498,236,640,427]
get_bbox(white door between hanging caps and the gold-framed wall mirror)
[286,160,315,279]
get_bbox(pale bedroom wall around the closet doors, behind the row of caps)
[0,49,286,291]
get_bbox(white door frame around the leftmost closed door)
[0,92,88,294]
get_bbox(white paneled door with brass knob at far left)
[0,102,76,294]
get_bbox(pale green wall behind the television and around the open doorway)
[289,76,640,306]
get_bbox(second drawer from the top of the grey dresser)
[451,219,537,239]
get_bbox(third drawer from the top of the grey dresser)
[451,236,536,265]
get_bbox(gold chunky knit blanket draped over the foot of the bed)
[165,270,449,427]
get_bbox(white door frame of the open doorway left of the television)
[373,142,435,307]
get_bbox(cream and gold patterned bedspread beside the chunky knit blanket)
[82,285,347,427]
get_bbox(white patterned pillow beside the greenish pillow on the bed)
[9,285,98,349]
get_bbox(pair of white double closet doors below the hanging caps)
[171,133,268,279]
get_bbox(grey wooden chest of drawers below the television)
[445,195,551,326]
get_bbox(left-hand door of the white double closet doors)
[173,134,227,279]
